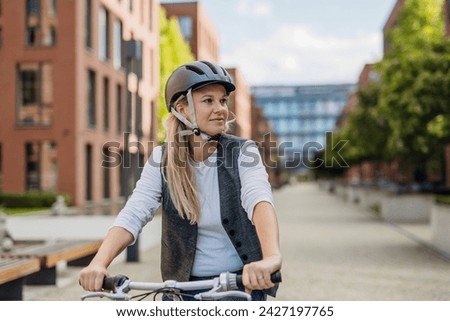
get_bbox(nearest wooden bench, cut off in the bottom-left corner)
[0,258,41,301]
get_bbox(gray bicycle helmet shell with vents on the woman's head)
[165,61,236,112]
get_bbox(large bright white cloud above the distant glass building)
[222,25,382,85]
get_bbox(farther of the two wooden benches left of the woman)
[1,240,101,285]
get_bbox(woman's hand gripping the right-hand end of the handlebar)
[242,256,281,293]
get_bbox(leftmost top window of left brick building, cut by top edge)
[25,0,58,47]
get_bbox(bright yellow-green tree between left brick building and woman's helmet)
[158,7,195,143]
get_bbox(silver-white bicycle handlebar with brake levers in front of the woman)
[81,272,281,301]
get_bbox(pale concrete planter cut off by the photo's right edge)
[431,204,450,255]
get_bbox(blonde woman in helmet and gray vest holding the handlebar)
[80,61,281,300]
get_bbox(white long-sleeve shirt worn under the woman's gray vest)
[113,141,273,276]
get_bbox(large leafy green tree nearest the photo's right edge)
[376,0,450,182]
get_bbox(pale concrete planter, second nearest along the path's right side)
[381,194,434,223]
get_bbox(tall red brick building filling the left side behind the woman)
[0,0,159,206]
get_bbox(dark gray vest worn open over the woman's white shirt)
[161,135,262,281]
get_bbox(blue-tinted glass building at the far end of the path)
[252,84,356,170]
